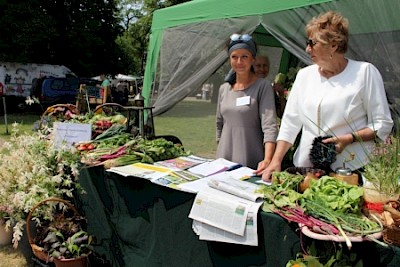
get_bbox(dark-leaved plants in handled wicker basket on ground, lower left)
[27,198,94,267]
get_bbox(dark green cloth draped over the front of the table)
[78,167,400,267]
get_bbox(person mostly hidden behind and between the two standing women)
[253,55,286,118]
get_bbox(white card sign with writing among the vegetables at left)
[53,122,92,146]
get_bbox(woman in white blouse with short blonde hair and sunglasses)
[262,11,393,181]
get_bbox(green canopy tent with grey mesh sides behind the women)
[142,0,400,126]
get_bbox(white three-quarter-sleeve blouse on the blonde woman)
[277,59,393,170]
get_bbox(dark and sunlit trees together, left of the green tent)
[0,0,187,76]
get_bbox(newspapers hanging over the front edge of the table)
[189,178,263,244]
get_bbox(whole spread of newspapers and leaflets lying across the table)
[107,157,263,246]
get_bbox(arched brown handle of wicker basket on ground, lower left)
[26,198,79,262]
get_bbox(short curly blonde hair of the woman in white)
[306,11,349,54]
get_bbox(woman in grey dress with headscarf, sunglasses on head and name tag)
[216,34,277,170]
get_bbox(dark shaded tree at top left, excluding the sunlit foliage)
[0,0,122,76]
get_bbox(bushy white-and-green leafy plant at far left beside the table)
[0,123,83,247]
